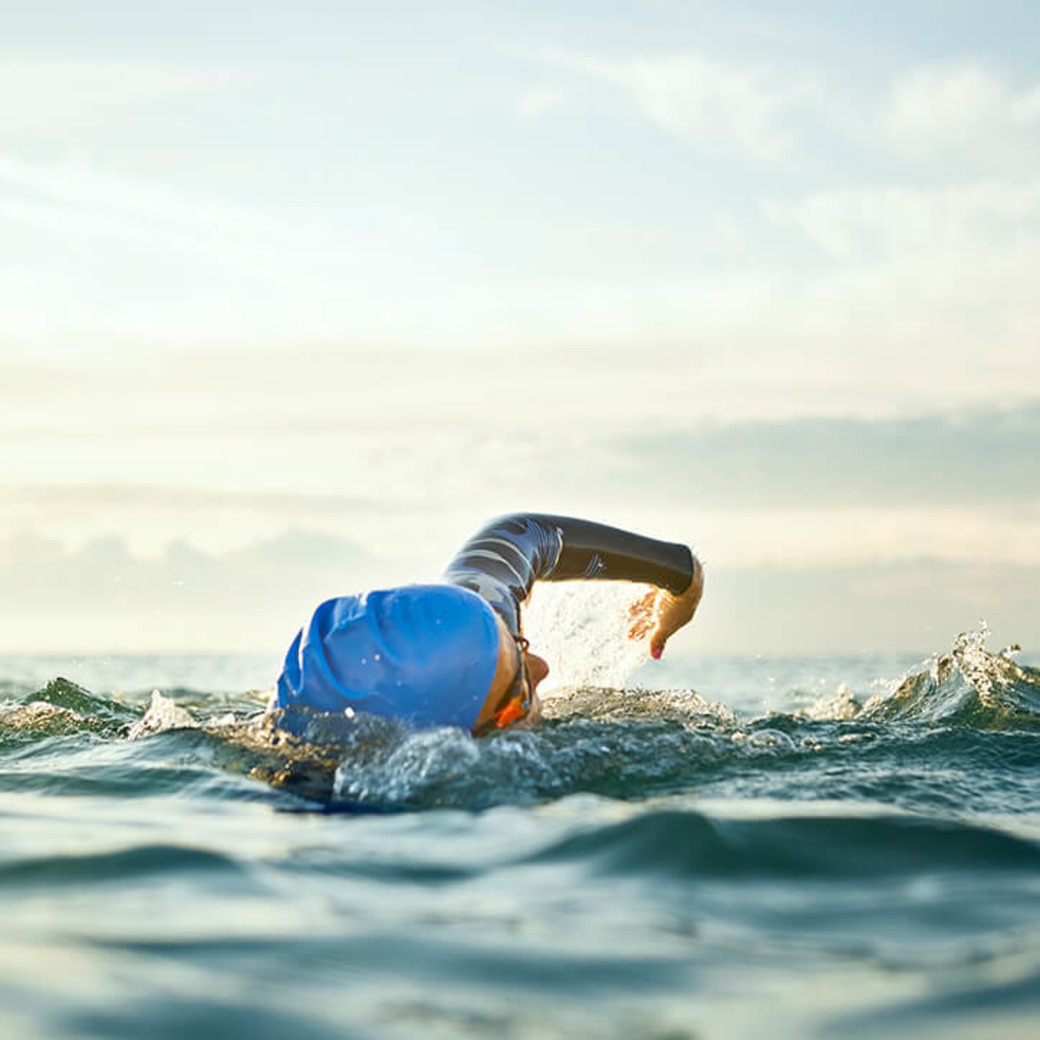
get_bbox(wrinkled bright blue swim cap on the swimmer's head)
[277,584,499,729]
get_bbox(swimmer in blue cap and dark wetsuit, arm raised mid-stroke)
[271,514,704,736]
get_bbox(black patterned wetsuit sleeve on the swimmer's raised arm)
[444,513,694,633]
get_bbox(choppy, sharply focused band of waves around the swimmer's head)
[0,628,1040,813]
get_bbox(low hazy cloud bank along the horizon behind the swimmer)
[0,530,1040,653]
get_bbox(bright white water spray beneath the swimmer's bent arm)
[524,581,651,695]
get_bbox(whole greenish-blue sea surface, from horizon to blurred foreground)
[0,630,1040,1040]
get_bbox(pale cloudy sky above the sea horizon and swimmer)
[0,0,1040,654]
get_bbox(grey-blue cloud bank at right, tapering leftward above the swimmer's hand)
[618,404,1040,510]
